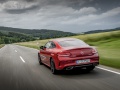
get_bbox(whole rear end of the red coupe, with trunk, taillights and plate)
[56,38,99,70]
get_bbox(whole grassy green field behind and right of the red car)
[17,30,120,69]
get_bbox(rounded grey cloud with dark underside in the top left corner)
[0,0,39,14]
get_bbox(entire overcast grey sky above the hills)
[0,0,120,33]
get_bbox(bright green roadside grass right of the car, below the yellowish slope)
[92,38,120,69]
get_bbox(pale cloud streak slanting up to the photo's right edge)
[62,7,120,25]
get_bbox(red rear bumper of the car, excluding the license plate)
[55,54,99,70]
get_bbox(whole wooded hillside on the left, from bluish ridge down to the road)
[0,27,76,44]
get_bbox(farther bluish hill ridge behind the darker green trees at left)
[0,27,76,39]
